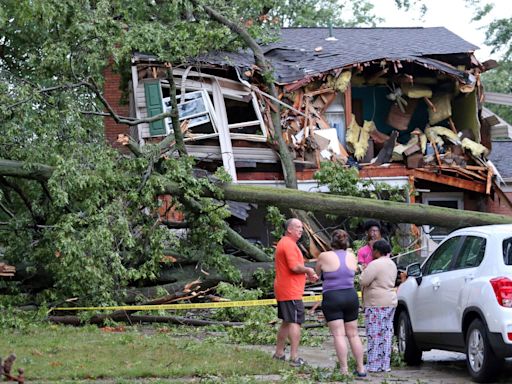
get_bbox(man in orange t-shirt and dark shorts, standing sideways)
[273,219,318,367]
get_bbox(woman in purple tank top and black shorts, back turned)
[315,229,366,377]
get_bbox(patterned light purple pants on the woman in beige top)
[364,307,396,372]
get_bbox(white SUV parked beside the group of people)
[395,224,512,383]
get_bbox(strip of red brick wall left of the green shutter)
[103,64,130,148]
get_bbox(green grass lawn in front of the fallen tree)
[0,325,289,383]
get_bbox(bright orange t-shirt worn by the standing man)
[274,236,306,301]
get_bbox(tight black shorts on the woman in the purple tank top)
[322,288,359,323]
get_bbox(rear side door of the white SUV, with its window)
[437,236,486,332]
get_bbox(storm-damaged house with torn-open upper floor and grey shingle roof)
[106,27,512,250]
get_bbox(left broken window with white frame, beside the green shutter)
[163,90,218,141]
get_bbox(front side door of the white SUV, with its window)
[408,236,463,332]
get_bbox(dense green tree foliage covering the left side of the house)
[0,0,382,305]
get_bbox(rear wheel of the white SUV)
[466,319,504,383]
